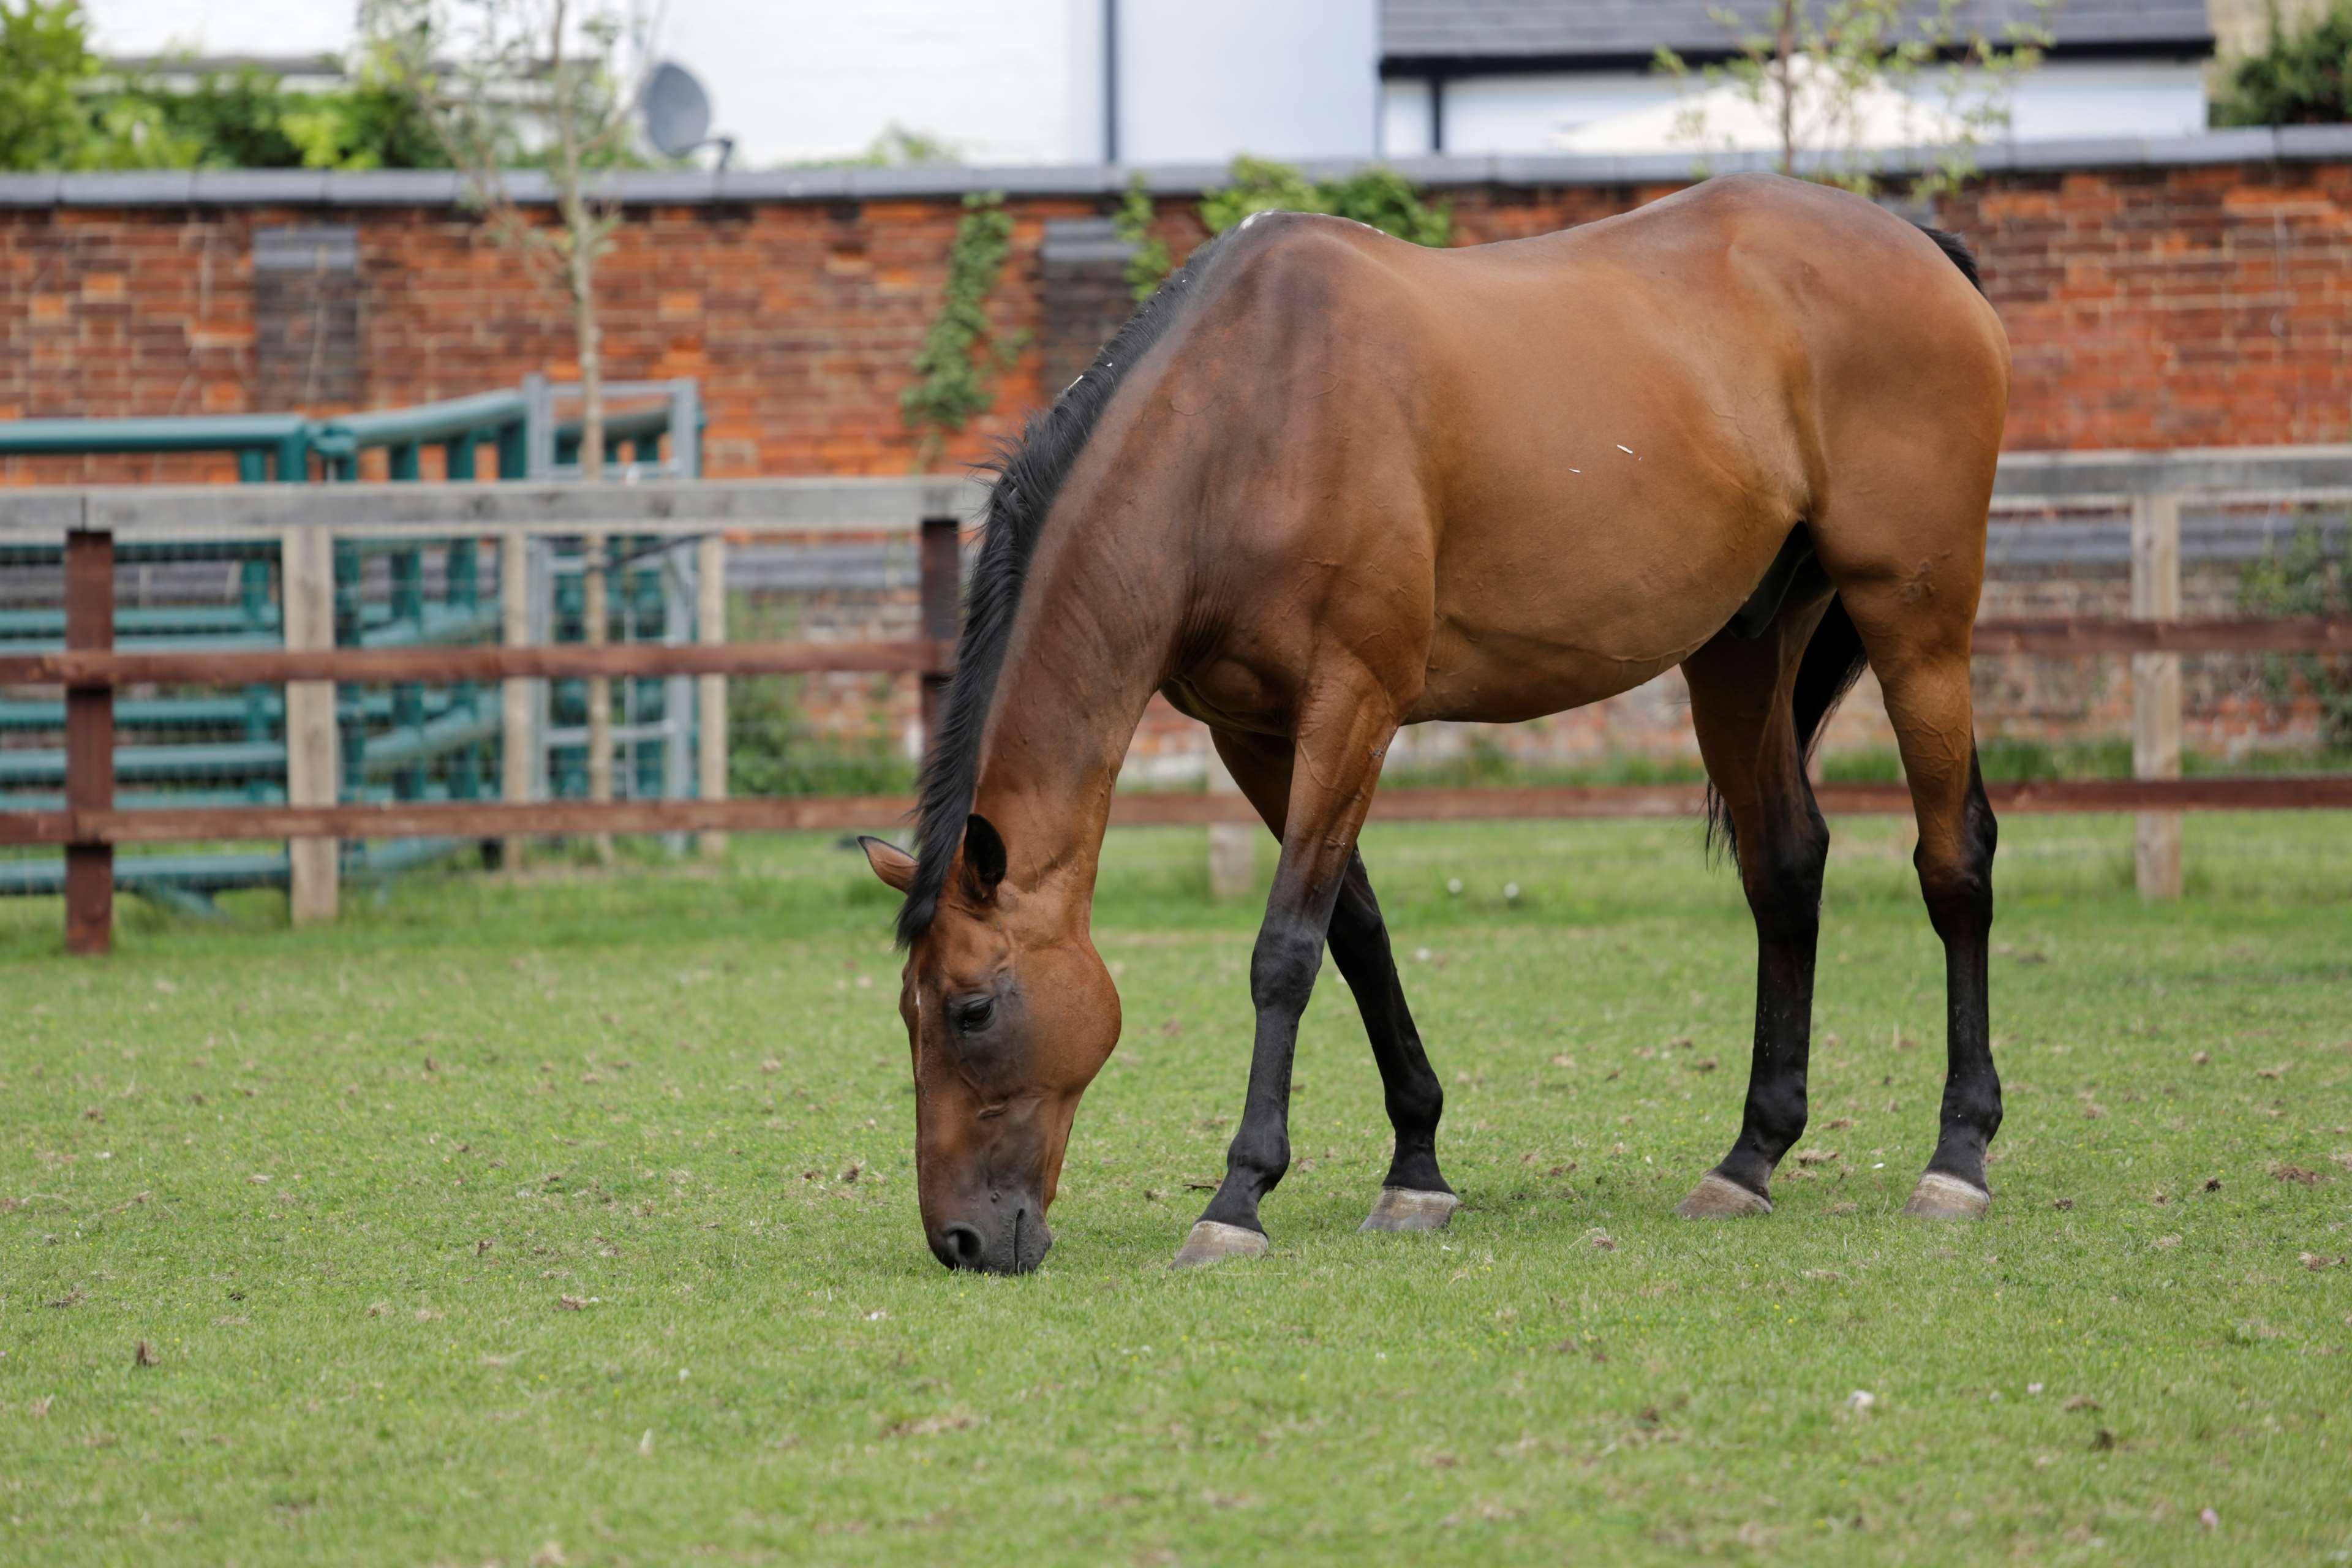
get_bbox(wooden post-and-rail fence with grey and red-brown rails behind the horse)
[0,454,2352,952]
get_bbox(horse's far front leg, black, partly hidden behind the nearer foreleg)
[1213,731,1461,1229]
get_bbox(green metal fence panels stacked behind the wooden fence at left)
[0,379,703,905]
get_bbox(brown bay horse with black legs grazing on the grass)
[865,176,2008,1272]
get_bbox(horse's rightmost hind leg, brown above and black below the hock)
[1832,557,2002,1220]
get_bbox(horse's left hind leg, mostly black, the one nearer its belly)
[1675,600,1830,1220]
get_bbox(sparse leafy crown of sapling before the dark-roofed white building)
[1656,0,2051,200]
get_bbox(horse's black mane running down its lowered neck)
[899,239,1223,948]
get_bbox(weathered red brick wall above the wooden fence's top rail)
[0,162,2352,482]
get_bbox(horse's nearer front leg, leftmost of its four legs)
[1176,679,1397,1270]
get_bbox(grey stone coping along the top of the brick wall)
[0,124,2352,207]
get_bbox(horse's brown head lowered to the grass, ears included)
[861,816,1120,1274]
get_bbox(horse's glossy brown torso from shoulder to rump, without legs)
[1167,176,2007,719]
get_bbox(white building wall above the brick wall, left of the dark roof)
[85,0,1378,167]
